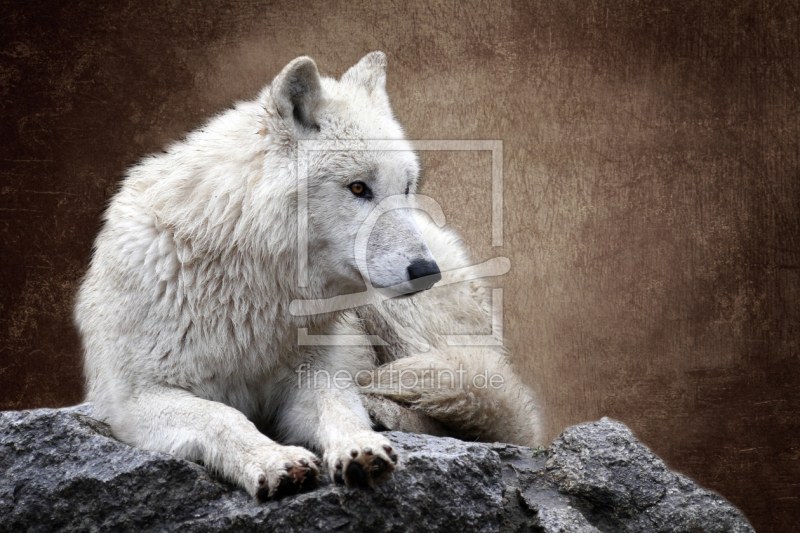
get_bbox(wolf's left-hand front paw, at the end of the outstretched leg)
[244,444,322,502]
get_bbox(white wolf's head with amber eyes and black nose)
[265,52,441,300]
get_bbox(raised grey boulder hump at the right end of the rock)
[547,418,753,533]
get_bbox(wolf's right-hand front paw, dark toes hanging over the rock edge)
[325,431,398,487]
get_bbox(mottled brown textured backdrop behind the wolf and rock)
[0,0,800,532]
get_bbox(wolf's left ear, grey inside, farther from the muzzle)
[270,56,322,129]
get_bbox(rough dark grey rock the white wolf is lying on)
[0,404,753,533]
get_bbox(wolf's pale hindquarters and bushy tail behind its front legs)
[349,215,544,446]
